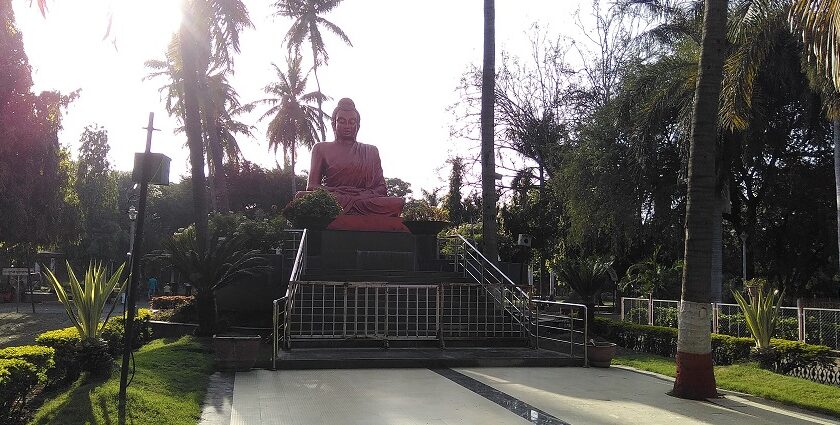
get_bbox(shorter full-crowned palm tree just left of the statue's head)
[243,54,326,194]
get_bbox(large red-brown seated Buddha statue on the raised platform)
[298,98,407,232]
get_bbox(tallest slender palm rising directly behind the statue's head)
[274,0,353,141]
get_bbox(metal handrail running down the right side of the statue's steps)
[438,235,589,366]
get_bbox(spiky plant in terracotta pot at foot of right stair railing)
[551,255,615,367]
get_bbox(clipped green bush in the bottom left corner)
[0,359,38,424]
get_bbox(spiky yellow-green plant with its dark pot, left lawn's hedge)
[44,262,128,379]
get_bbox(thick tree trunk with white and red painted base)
[672,0,727,399]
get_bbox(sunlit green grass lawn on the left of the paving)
[31,337,213,425]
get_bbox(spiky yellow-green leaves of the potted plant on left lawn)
[44,262,126,340]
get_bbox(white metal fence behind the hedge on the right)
[621,297,840,350]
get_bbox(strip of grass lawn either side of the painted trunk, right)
[613,353,840,417]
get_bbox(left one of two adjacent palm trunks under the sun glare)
[179,17,207,254]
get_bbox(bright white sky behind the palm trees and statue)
[14,0,580,195]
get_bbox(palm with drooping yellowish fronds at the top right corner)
[789,0,840,282]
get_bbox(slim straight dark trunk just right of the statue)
[481,0,499,263]
